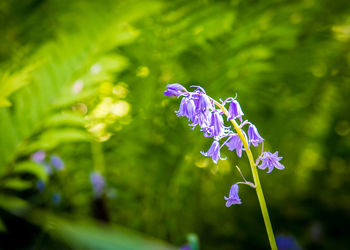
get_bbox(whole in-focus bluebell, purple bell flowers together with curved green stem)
[164,83,284,250]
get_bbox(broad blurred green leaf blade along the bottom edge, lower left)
[29,211,177,250]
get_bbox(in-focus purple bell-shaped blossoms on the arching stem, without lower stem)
[164,83,284,206]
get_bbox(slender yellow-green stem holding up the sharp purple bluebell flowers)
[213,100,277,250]
